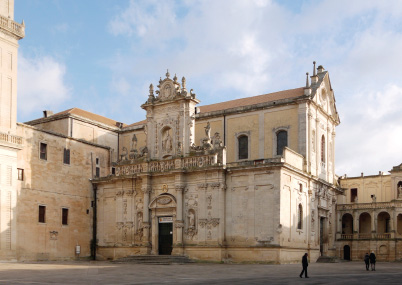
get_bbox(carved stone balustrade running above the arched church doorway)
[115,154,218,176]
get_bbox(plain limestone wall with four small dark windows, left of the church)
[14,125,109,260]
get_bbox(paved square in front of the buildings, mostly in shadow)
[0,261,402,285]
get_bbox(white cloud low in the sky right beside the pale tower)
[18,53,70,120]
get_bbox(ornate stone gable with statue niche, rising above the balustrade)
[141,71,200,159]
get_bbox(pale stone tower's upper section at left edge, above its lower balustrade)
[0,0,25,133]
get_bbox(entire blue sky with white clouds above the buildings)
[15,0,402,176]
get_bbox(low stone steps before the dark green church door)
[112,255,194,265]
